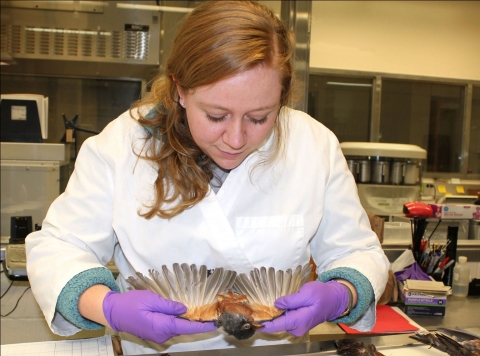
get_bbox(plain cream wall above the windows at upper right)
[310,1,480,80]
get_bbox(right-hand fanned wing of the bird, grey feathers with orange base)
[233,264,312,322]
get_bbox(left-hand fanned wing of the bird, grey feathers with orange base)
[127,263,237,321]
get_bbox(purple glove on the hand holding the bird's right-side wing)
[258,281,348,337]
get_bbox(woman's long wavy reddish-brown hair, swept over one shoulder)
[131,1,295,219]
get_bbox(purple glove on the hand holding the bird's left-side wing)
[103,290,217,344]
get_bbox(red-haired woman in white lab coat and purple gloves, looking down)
[27,1,388,354]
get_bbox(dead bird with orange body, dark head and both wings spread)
[127,263,312,340]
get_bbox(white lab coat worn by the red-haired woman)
[27,110,388,353]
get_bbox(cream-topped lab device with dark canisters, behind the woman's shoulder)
[340,142,427,216]
